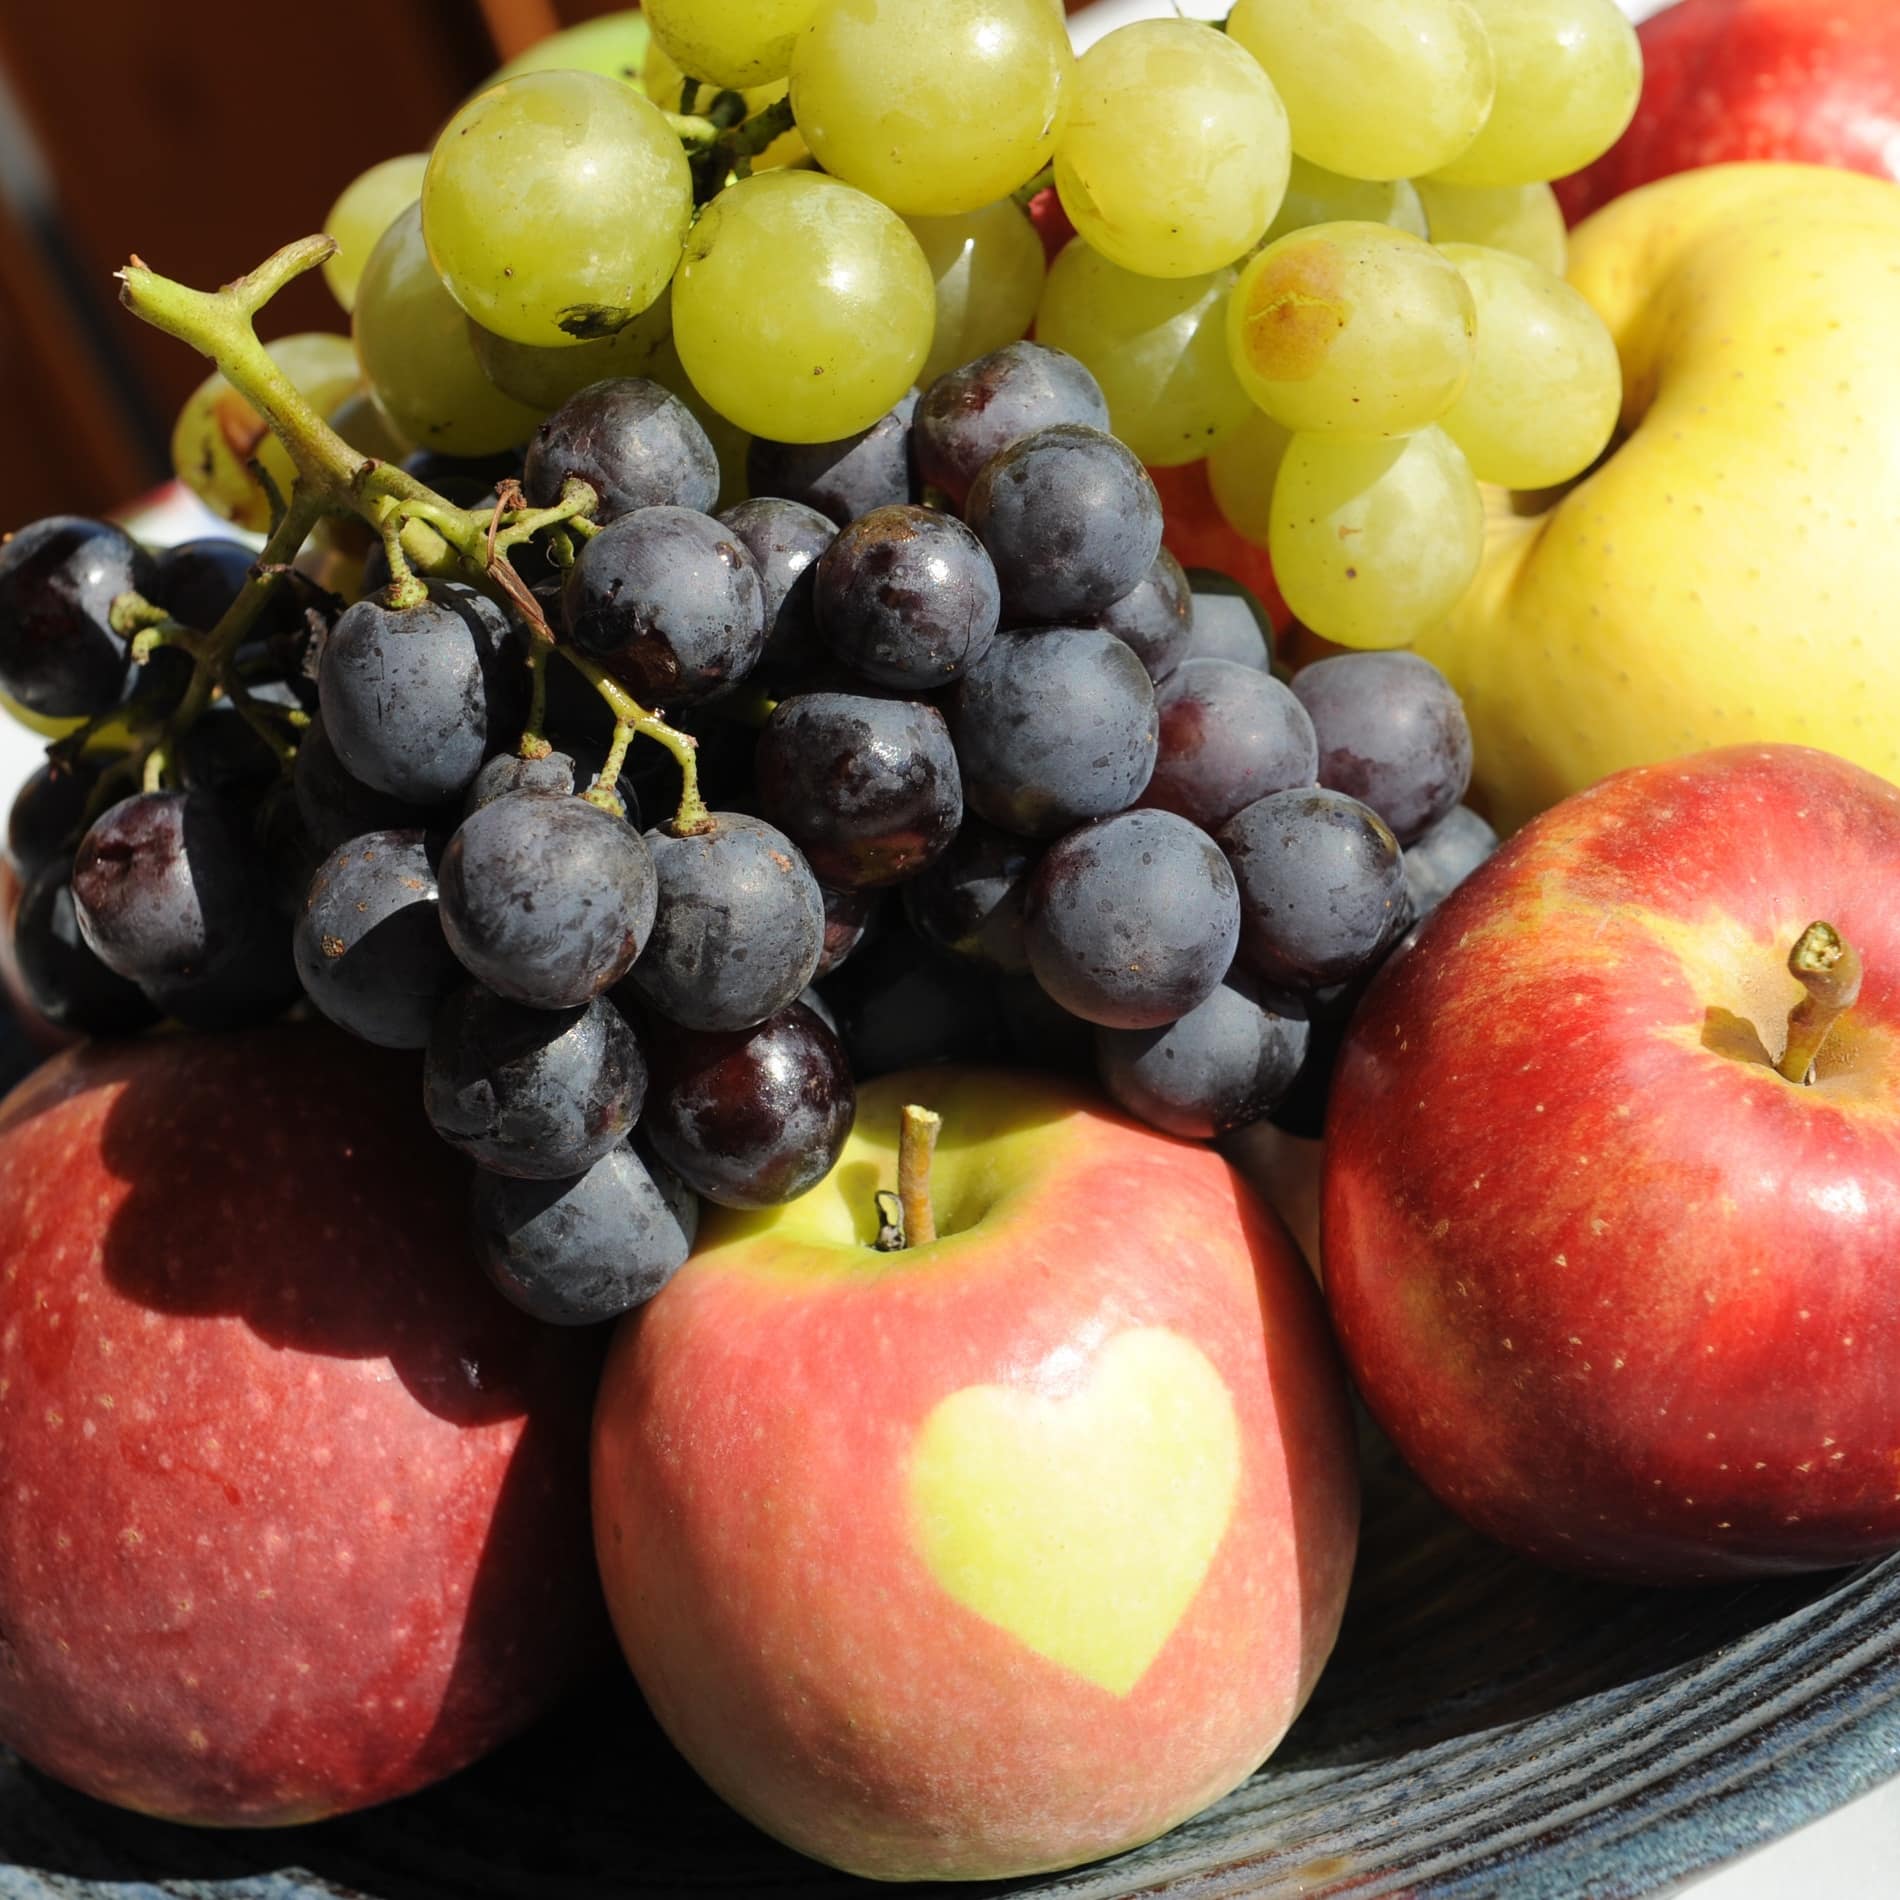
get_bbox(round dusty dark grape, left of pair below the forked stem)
[439,792,657,1010]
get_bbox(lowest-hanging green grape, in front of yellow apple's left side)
[1269,428,1484,646]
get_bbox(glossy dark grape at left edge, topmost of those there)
[0,515,152,718]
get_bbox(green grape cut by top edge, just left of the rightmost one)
[1227,0,1511,179]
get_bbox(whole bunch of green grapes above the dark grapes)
[167,0,1640,630]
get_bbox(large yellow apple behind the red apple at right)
[1417,163,1900,830]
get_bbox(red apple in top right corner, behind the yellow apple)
[1556,0,1900,224]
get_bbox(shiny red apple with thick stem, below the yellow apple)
[1321,745,1900,1583]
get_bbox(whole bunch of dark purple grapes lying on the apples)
[0,344,1495,1324]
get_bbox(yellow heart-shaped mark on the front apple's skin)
[910,1326,1241,1695]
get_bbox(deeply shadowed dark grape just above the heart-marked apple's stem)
[825,931,1005,1081]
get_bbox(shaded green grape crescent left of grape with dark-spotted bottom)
[355,205,542,456]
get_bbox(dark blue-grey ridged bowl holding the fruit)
[0,1427,1900,1900]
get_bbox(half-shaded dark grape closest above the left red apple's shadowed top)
[293,830,462,1049]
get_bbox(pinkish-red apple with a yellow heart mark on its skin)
[595,1070,1359,1879]
